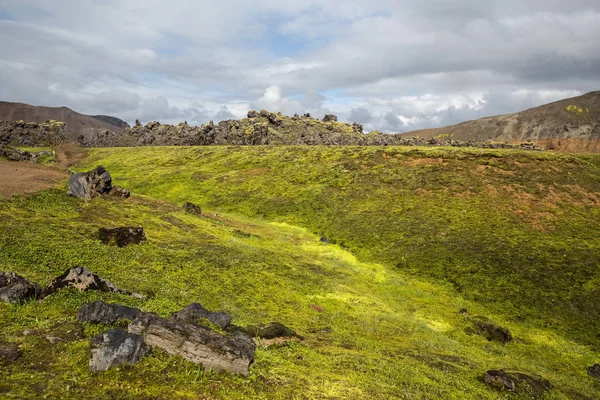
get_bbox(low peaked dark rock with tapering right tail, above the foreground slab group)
[44,267,144,298]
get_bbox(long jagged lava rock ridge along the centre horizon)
[81,110,535,150]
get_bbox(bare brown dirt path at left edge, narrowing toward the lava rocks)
[0,146,87,198]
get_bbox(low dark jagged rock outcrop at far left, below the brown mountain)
[0,121,70,146]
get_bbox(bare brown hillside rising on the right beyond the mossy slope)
[404,91,600,143]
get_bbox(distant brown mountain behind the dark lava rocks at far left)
[0,101,129,141]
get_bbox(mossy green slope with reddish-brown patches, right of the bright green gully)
[83,147,600,346]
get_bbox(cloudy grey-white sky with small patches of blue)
[0,0,600,132]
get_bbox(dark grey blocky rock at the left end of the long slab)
[89,329,148,372]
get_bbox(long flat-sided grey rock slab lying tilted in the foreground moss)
[129,314,256,375]
